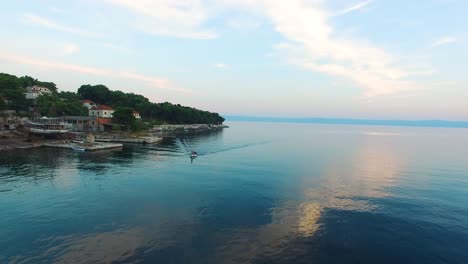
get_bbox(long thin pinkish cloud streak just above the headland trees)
[0,52,186,93]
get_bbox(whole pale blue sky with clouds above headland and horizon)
[0,0,468,120]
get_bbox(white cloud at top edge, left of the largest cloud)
[106,0,217,39]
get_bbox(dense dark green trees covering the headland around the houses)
[0,73,224,125]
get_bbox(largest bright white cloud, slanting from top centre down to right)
[225,0,421,97]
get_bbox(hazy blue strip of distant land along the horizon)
[225,115,468,128]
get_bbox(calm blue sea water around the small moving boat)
[0,123,468,263]
